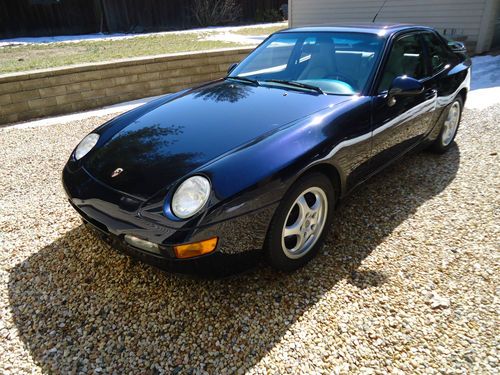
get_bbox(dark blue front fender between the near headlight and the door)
[199,98,370,223]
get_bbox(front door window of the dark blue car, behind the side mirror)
[378,34,426,92]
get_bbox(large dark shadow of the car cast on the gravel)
[9,146,460,373]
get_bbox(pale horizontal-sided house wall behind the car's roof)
[289,0,498,53]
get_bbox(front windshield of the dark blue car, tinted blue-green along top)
[229,32,384,95]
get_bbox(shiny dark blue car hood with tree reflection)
[84,80,347,199]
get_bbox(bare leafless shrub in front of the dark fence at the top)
[192,0,241,26]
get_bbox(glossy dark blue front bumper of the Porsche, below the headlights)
[62,167,278,273]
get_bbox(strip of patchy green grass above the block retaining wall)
[0,25,285,73]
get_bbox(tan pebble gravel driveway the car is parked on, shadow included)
[0,105,500,374]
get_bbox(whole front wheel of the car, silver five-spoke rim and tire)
[264,173,335,271]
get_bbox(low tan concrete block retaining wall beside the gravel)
[0,48,252,124]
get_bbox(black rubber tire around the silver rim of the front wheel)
[264,172,336,272]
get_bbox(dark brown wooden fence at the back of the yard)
[0,0,287,38]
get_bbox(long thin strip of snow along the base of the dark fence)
[0,22,287,48]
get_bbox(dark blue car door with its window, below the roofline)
[370,32,436,170]
